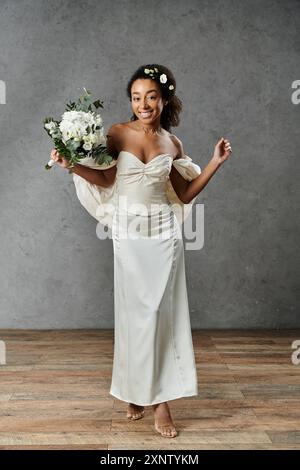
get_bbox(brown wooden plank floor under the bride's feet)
[0,330,300,450]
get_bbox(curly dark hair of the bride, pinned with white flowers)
[126,64,182,132]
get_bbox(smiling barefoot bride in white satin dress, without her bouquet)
[51,64,231,437]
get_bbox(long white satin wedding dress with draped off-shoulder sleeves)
[73,150,201,406]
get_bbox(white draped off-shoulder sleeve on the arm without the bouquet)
[167,155,201,224]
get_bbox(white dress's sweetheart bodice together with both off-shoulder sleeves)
[72,150,201,228]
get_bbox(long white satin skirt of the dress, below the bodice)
[110,205,198,406]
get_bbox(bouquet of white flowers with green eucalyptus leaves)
[43,88,113,170]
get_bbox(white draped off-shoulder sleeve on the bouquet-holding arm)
[72,157,117,228]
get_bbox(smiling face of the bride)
[131,78,166,124]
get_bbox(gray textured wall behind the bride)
[0,0,300,328]
